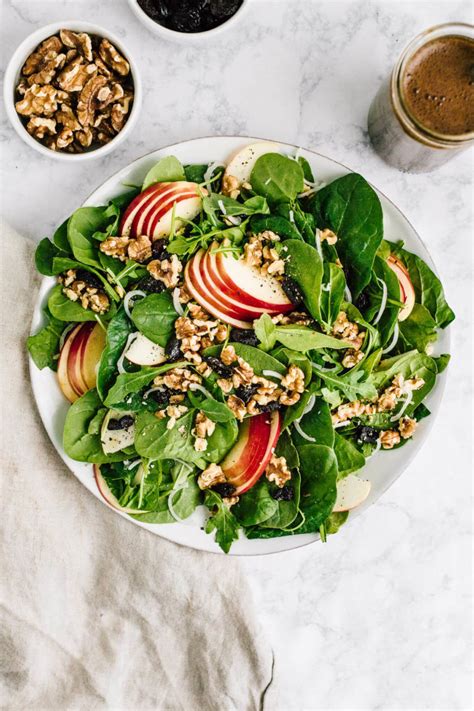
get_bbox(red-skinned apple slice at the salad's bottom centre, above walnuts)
[221,411,281,496]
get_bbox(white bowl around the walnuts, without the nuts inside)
[3,20,142,162]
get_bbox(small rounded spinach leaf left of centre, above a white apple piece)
[132,291,178,348]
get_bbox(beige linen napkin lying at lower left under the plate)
[0,225,272,711]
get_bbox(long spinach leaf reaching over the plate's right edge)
[391,243,455,328]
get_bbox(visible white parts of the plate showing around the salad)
[30,136,449,555]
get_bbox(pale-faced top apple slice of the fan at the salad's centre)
[215,252,294,313]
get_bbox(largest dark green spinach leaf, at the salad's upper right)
[311,173,383,299]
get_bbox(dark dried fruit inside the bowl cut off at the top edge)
[138,0,243,32]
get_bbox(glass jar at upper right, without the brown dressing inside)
[368,23,474,173]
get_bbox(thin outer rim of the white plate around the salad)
[28,135,451,557]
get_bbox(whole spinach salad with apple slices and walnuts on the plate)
[28,142,454,553]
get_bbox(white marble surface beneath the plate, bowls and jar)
[0,0,472,711]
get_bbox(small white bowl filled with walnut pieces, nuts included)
[4,21,142,161]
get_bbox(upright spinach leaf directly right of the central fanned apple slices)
[281,239,323,321]
